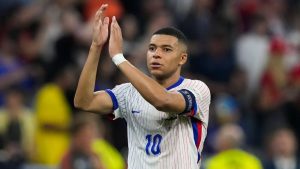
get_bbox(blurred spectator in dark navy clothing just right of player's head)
[189,28,236,93]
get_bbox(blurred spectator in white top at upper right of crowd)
[236,15,269,97]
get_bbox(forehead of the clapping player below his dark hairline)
[150,35,178,46]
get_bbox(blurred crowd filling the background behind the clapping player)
[0,0,300,169]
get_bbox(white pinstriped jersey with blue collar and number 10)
[107,77,210,169]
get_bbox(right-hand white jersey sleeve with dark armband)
[179,81,211,124]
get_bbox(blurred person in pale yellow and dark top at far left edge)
[0,88,35,169]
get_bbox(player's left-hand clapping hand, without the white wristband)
[92,4,109,47]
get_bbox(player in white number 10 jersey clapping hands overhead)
[74,4,210,169]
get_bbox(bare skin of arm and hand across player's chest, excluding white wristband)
[109,17,186,114]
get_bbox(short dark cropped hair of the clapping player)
[152,27,187,46]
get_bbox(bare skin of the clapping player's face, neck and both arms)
[74,4,187,114]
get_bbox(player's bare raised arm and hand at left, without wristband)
[74,4,113,114]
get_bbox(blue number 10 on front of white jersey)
[145,134,162,155]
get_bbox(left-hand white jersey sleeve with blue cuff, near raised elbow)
[105,83,130,119]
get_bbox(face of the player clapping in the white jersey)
[147,35,187,78]
